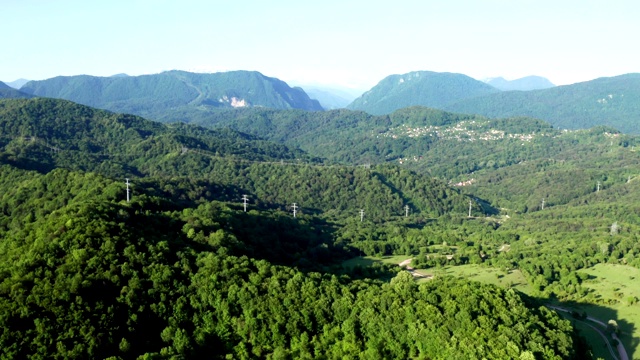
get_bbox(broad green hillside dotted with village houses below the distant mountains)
[186,107,640,218]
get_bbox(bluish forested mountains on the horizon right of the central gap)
[347,71,640,134]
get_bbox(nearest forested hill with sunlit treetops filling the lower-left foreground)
[0,170,579,359]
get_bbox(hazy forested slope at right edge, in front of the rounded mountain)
[442,74,640,134]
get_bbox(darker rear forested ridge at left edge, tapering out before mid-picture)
[0,98,308,176]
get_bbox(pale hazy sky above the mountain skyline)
[0,0,640,89]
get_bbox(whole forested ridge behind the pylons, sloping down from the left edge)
[0,98,476,218]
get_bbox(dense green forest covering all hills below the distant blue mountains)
[0,99,640,359]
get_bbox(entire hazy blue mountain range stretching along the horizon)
[11,67,640,134]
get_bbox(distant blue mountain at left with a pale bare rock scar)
[21,70,322,119]
